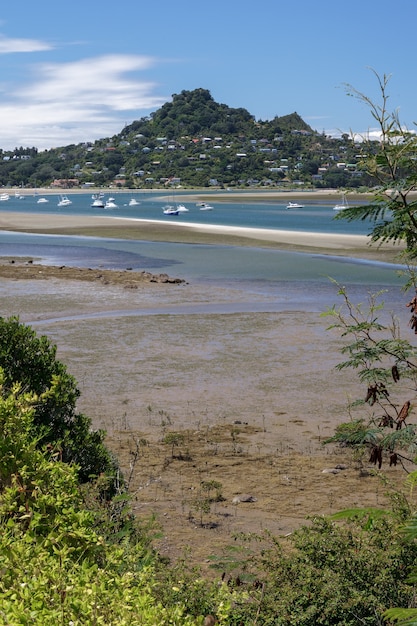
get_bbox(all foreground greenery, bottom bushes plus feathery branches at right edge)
[4,72,417,626]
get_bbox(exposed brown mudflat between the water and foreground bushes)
[0,261,410,567]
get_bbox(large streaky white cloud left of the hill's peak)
[0,55,168,150]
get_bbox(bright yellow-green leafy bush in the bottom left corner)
[0,370,237,626]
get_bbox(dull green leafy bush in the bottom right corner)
[221,511,417,626]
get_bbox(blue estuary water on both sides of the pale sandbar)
[0,191,402,310]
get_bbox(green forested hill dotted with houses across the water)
[0,89,368,189]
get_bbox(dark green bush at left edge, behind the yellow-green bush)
[0,317,117,482]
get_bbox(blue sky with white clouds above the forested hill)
[0,0,417,150]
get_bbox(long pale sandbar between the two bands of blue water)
[0,211,401,262]
